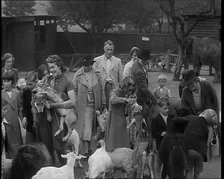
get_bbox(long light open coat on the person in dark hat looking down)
[73,68,106,139]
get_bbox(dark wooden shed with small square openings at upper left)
[1,16,57,71]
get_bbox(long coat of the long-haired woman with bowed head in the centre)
[105,88,130,151]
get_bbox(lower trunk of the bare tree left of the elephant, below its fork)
[173,45,183,81]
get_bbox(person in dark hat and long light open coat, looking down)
[73,56,106,157]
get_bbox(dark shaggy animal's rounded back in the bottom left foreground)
[10,143,52,179]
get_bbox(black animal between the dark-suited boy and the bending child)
[159,117,189,179]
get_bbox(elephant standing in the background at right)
[186,37,221,83]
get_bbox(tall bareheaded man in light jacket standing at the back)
[93,40,123,109]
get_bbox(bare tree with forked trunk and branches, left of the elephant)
[159,0,218,80]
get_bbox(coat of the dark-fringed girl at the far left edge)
[2,89,23,158]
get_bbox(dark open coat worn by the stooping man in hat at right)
[181,81,219,116]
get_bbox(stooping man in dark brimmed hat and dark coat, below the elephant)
[181,69,219,115]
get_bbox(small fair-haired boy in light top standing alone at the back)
[153,74,171,101]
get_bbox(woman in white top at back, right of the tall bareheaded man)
[123,47,140,78]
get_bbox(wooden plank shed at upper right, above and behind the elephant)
[184,15,221,40]
